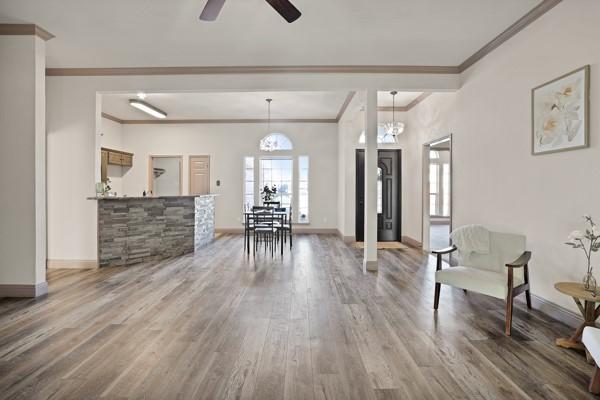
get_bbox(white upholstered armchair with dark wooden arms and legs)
[433,232,531,335]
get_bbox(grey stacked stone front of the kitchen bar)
[98,195,215,267]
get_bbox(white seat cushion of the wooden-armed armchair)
[435,266,524,299]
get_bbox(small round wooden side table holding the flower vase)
[554,282,600,350]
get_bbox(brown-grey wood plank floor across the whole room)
[0,235,593,400]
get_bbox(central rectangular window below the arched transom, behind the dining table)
[260,158,294,207]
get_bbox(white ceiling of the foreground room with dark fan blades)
[0,0,541,67]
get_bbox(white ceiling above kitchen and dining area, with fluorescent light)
[102,92,348,120]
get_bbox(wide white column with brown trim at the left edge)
[0,25,51,297]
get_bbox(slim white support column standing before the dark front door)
[363,89,378,273]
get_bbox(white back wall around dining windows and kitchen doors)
[118,123,338,229]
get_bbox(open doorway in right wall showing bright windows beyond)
[423,136,452,250]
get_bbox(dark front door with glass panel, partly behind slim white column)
[356,150,402,242]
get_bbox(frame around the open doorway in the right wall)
[421,133,454,251]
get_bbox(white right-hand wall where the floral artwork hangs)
[407,0,600,310]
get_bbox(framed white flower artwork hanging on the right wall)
[531,65,590,155]
